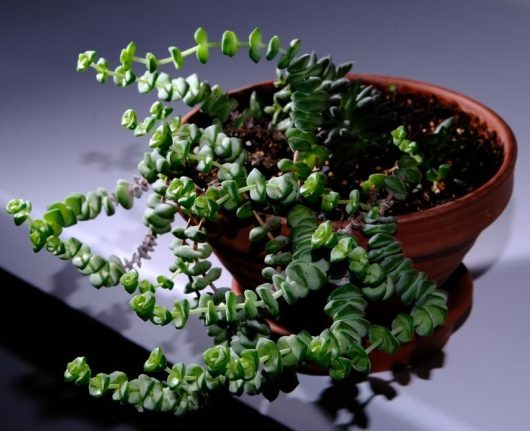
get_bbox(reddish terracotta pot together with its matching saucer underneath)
[184,75,517,373]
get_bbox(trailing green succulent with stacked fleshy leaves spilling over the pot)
[6,28,451,415]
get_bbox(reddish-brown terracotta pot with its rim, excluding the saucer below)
[184,75,517,288]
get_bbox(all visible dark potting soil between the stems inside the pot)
[195,85,502,215]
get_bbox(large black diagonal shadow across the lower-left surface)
[0,272,287,431]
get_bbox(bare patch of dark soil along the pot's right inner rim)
[376,89,502,214]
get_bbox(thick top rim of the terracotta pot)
[182,73,517,224]
